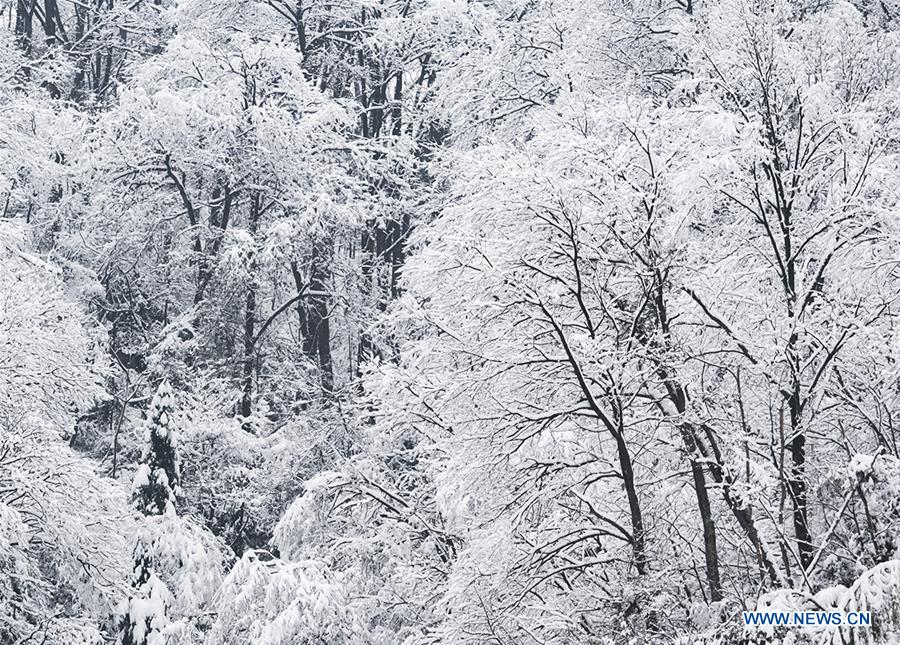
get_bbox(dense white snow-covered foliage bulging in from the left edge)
[0,220,134,645]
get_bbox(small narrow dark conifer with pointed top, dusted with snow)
[132,381,180,515]
